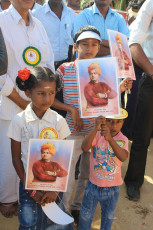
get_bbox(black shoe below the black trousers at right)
[127,185,140,201]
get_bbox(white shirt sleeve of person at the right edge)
[129,0,153,64]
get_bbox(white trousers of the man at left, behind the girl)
[0,120,18,203]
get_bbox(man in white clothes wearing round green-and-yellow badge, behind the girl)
[0,0,54,217]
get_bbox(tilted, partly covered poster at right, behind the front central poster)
[108,30,136,80]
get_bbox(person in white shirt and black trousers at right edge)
[125,0,153,201]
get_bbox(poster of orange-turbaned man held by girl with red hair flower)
[25,139,73,192]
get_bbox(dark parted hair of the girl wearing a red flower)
[16,66,61,91]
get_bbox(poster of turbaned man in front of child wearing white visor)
[77,58,120,118]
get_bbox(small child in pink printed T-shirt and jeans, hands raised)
[79,109,129,230]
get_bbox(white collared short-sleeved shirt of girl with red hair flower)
[7,105,71,170]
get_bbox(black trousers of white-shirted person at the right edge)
[125,74,153,187]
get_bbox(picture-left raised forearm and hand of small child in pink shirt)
[82,116,105,152]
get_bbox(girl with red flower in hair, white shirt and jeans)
[8,67,70,230]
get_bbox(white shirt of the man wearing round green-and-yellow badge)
[0,5,54,120]
